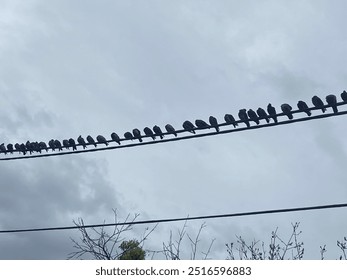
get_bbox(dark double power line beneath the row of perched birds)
[0,106,347,160]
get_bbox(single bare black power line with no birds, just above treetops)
[0,203,347,233]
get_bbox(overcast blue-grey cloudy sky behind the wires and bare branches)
[0,0,347,259]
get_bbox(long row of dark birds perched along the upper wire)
[0,91,347,155]
